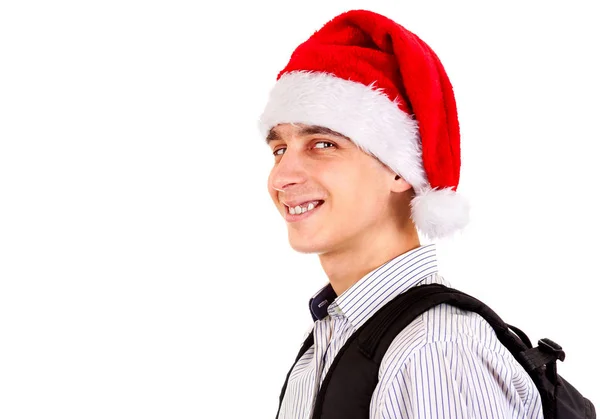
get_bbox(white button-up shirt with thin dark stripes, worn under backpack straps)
[278,244,543,419]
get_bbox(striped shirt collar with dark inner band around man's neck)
[308,243,438,329]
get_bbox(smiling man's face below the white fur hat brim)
[267,124,394,254]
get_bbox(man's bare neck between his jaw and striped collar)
[319,231,420,295]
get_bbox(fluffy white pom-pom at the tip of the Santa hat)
[410,188,469,239]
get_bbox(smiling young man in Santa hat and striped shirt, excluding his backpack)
[261,11,542,419]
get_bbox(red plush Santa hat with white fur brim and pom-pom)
[259,10,469,238]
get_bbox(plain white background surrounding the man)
[0,0,600,419]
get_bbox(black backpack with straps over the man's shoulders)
[276,284,596,419]
